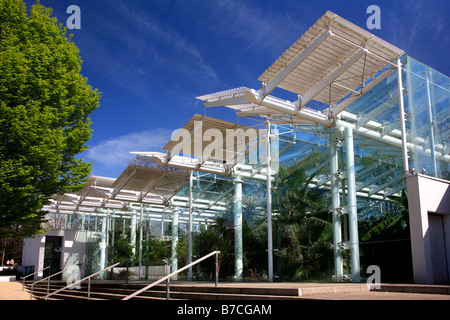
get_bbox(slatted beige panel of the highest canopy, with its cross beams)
[258,11,404,105]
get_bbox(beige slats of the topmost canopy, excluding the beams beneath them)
[258,11,404,103]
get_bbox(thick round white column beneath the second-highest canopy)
[233,177,244,281]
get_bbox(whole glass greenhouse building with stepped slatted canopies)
[24,12,450,283]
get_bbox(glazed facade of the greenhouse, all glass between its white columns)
[41,56,450,281]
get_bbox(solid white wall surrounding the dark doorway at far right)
[406,174,450,284]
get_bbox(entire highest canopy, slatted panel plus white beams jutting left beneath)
[197,11,404,120]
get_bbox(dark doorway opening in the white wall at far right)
[428,213,450,283]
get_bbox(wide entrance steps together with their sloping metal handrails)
[22,251,369,300]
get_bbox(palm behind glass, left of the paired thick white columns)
[274,163,332,280]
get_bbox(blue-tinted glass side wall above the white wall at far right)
[405,57,450,180]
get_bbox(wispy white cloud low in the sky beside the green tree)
[86,129,172,167]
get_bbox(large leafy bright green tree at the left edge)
[0,0,100,234]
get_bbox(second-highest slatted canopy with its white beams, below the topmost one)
[132,113,274,179]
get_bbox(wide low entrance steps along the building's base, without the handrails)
[22,281,368,300]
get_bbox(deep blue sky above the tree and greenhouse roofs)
[26,0,450,177]
